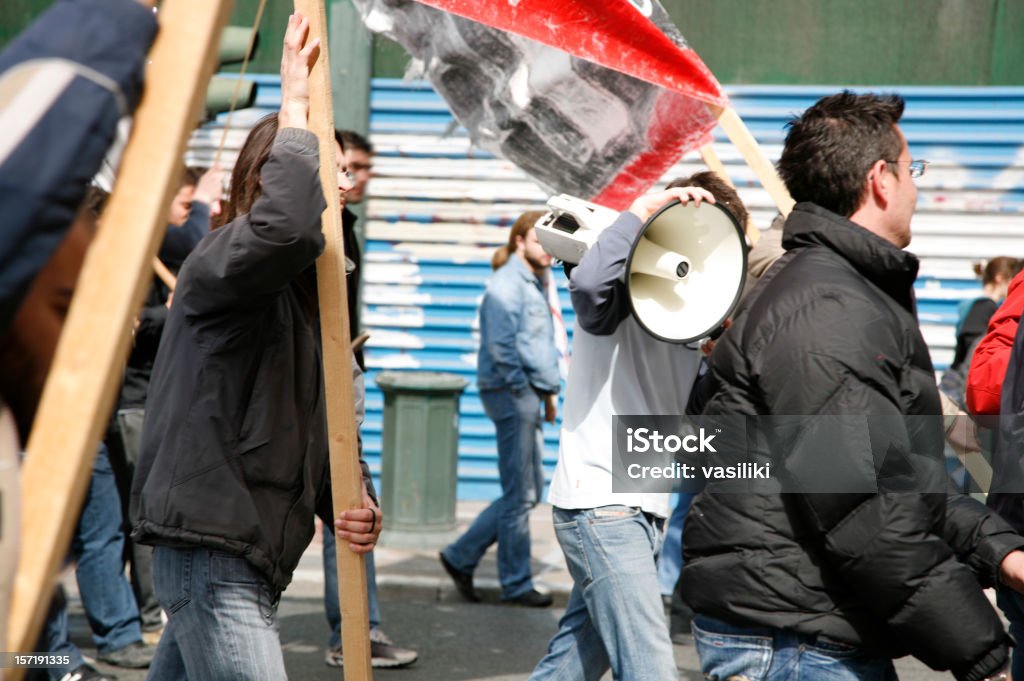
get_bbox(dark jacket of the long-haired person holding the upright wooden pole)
[131,128,373,590]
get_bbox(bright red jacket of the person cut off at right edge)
[967,271,1024,416]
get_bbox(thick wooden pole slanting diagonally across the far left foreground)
[4,0,231,667]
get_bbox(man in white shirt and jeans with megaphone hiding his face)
[530,178,745,681]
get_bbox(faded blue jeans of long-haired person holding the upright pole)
[146,546,288,681]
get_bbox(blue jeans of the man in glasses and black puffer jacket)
[693,614,896,681]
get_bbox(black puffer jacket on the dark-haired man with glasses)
[682,203,1024,680]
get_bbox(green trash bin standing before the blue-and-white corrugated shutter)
[377,372,469,548]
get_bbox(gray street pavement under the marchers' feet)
[66,502,952,681]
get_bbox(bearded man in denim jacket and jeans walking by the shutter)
[440,212,560,607]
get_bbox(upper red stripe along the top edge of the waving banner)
[409,0,728,107]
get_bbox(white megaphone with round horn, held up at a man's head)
[536,195,746,343]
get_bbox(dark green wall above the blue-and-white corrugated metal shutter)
[0,0,1024,85]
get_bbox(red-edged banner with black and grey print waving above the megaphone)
[355,0,726,209]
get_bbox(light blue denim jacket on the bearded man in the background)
[476,255,560,394]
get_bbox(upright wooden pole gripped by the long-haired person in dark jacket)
[295,0,373,681]
